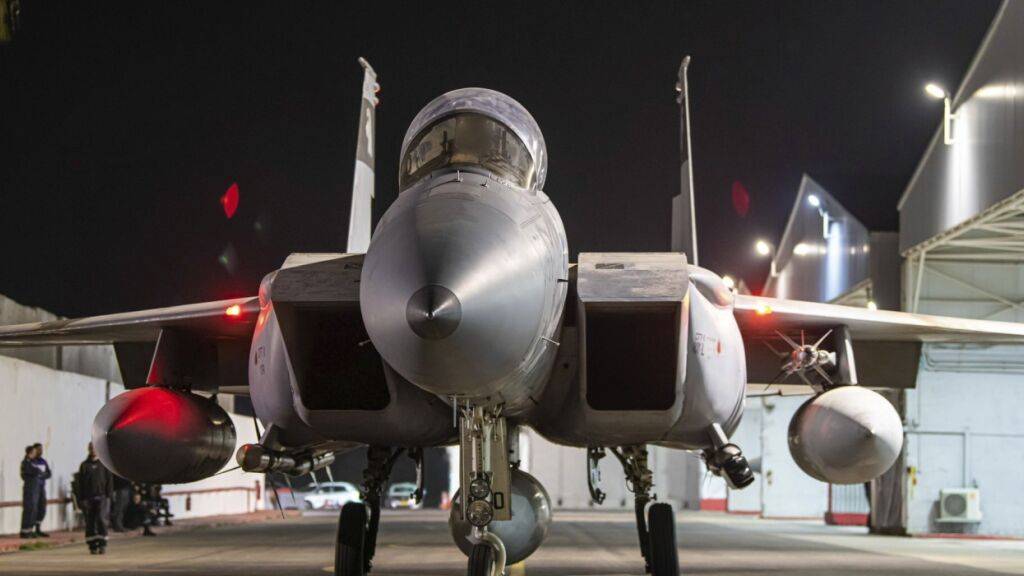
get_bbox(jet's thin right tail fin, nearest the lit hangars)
[672,56,697,265]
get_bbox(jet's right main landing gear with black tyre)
[606,445,679,576]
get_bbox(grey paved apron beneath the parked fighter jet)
[0,511,1024,576]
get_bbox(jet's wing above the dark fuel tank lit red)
[0,296,259,347]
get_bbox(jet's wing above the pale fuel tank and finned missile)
[734,294,1024,389]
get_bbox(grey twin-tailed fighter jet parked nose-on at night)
[0,60,1024,576]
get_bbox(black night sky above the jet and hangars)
[0,0,998,316]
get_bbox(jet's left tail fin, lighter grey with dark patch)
[345,58,380,254]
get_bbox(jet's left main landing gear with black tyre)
[334,446,423,576]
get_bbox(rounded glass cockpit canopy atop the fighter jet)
[398,88,547,192]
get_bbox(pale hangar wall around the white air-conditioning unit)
[905,344,1024,536]
